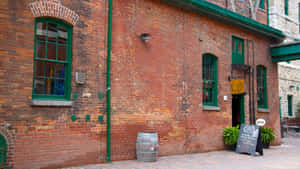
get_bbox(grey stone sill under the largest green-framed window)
[31,100,73,107]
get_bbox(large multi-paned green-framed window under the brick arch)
[32,18,72,100]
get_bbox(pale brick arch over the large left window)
[29,0,79,26]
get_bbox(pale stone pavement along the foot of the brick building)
[64,136,300,169]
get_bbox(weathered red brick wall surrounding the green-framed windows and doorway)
[0,0,280,169]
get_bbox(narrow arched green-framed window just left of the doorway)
[202,54,218,106]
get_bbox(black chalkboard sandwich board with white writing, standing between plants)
[236,124,263,156]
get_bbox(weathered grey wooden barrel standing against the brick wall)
[136,132,158,162]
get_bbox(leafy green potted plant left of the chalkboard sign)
[223,126,240,151]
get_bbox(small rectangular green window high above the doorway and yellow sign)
[232,36,244,64]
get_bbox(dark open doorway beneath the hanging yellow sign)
[232,95,245,126]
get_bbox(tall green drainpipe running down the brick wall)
[106,0,112,163]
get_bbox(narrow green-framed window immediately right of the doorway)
[256,65,268,108]
